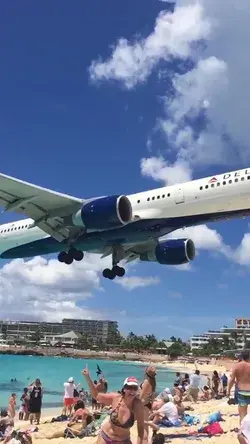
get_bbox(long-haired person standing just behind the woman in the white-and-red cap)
[140,366,156,444]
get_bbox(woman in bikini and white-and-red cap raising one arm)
[82,367,144,444]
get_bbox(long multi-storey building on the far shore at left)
[0,319,119,343]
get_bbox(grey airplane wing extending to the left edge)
[0,174,84,242]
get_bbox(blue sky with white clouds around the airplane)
[0,0,250,339]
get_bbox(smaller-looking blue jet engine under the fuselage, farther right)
[140,239,195,265]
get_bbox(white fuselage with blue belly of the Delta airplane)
[0,168,250,258]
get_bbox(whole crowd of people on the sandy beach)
[0,351,250,444]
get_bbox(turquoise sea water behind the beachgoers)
[0,355,175,408]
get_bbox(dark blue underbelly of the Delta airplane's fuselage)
[0,210,250,259]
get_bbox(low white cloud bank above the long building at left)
[0,255,110,321]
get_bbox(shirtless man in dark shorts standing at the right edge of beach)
[227,350,250,423]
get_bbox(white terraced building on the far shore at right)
[189,319,250,350]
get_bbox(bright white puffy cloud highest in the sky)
[89,3,211,89]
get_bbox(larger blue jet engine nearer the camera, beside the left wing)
[72,196,132,230]
